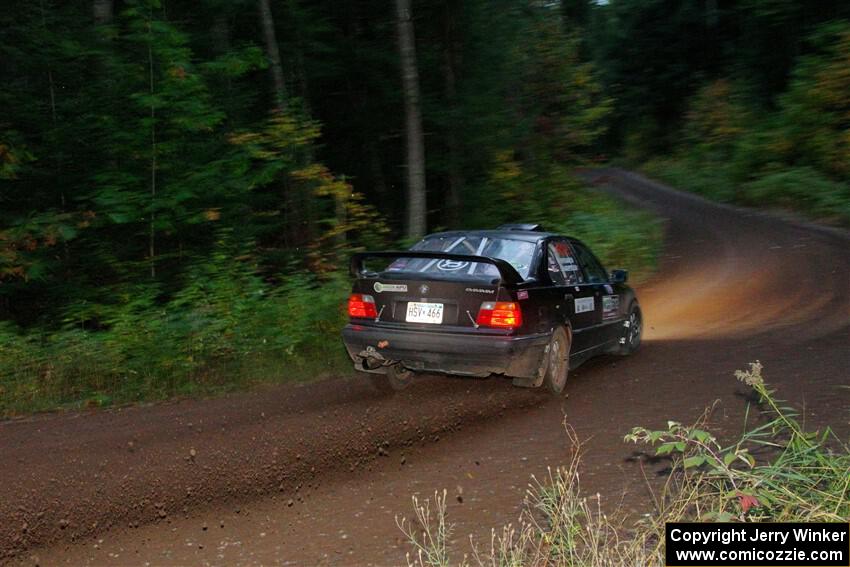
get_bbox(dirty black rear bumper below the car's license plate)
[342,324,549,378]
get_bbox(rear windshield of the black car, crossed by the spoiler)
[388,236,534,279]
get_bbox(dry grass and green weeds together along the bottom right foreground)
[397,363,850,567]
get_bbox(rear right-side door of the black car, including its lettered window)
[547,239,602,354]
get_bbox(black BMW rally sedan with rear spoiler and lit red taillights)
[342,225,642,393]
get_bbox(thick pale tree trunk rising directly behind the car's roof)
[395,0,428,239]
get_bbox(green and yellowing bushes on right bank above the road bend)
[644,22,850,226]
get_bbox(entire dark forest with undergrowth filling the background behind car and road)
[0,0,850,415]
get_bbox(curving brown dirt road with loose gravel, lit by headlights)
[0,170,850,565]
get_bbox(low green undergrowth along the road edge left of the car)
[0,256,349,415]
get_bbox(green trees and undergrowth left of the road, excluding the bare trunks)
[0,0,648,415]
